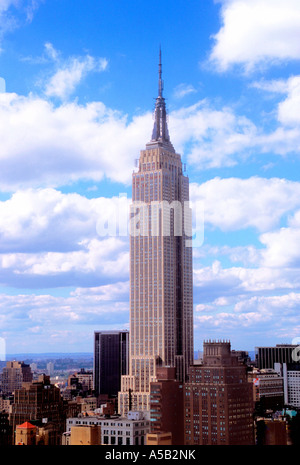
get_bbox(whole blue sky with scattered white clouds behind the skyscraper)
[0,0,300,354]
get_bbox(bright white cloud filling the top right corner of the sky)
[210,0,300,71]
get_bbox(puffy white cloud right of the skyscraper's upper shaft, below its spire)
[190,176,300,232]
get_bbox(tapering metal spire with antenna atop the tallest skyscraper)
[147,48,174,151]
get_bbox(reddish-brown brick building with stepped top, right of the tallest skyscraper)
[184,342,254,445]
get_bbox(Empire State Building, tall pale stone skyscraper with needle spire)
[119,53,193,414]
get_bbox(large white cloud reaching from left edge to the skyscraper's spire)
[0,93,152,191]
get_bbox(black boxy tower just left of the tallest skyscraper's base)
[94,331,129,397]
